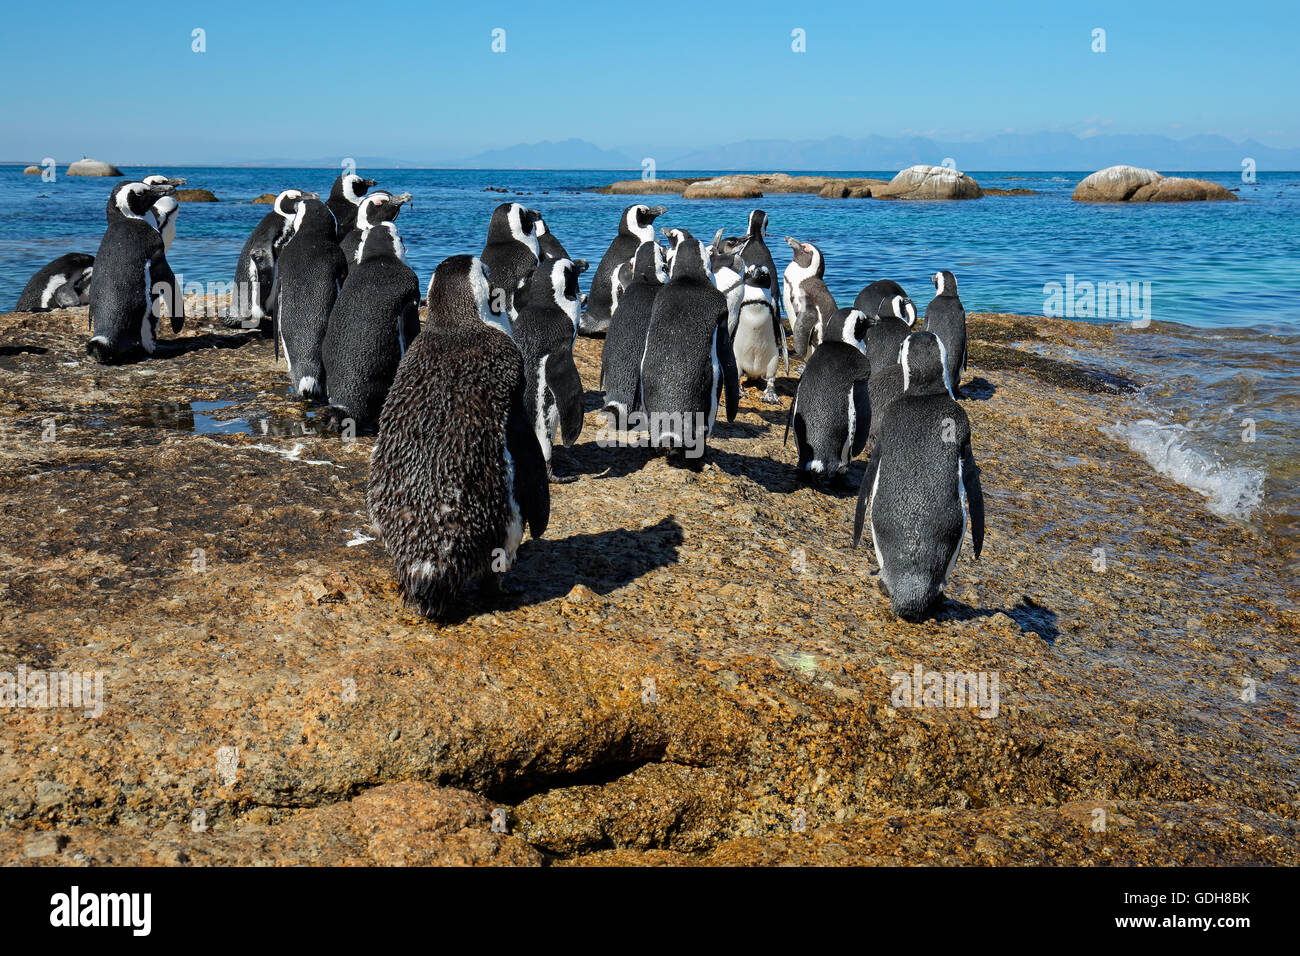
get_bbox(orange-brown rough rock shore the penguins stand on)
[0,308,1300,865]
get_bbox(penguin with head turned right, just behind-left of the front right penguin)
[783,308,872,488]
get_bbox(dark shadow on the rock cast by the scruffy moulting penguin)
[497,515,685,609]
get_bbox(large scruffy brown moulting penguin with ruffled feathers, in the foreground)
[365,255,550,619]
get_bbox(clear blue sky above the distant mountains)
[0,0,1300,164]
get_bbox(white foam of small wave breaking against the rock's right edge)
[1101,419,1266,520]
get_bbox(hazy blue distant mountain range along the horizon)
[45,133,1300,176]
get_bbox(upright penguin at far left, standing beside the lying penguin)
[86,182,185,364]
